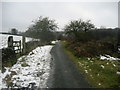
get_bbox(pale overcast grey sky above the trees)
[2,2,118,31]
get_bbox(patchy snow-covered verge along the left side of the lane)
[0,45,53,88]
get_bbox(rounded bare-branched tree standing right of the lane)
[64,19,94,40]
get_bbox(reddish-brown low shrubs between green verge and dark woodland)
[68,41,114,57]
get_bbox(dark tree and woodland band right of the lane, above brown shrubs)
[64,19,120,42]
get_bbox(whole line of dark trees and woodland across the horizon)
[7,16,120,49]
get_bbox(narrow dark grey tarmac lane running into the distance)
[48,42,91,88]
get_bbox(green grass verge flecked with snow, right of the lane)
[62,42,120,88]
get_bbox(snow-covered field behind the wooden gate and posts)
[0,34,38,49]
